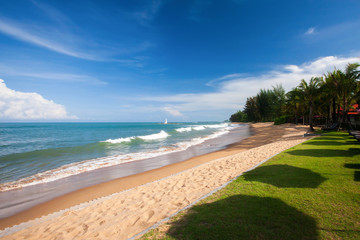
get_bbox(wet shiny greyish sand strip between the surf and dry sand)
[0,124,250,222]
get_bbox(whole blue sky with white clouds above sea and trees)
[0,0,360,122]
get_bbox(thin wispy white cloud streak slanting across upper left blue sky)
[0,18,150,62]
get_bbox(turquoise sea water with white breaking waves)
[0,122,238,190]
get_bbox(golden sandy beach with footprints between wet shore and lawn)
[0,123,308,239]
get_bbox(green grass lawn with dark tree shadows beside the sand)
[143,132,360,239]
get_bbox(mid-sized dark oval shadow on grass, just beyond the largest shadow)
[243,165,326,188]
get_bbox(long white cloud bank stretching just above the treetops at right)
[143,56,360,119]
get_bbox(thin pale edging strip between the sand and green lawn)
[128,139,309,240]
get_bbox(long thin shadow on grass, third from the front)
[287,148,360,157]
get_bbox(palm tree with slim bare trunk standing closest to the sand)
[298,77,322,131]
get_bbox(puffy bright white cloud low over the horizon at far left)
[0,79,77,120]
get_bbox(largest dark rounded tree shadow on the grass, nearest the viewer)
[167,195,318,240]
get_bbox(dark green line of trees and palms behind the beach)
[230,63,360,130]
